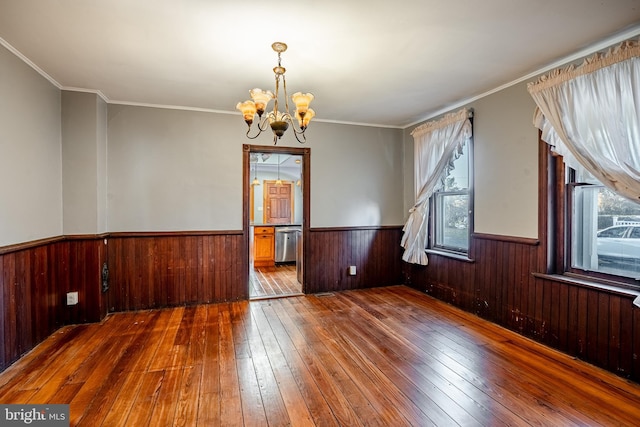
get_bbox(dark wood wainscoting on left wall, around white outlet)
[0,236,106,370]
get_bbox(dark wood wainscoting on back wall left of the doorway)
[108,231,248,312]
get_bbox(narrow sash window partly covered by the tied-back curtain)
[429,140,472,254]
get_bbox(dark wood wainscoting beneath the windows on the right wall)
[404,236,640,382]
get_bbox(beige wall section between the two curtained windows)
[471,83,538,238]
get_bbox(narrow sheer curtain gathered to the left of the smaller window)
[401,109,472,265]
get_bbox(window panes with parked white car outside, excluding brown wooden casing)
[566,169,640,278]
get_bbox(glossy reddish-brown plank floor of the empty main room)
[0,286,640,427]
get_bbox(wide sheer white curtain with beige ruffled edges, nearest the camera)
[528,41,640,202]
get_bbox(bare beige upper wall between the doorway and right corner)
[309,123,404,227]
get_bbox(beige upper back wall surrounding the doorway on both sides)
[107,105,403,231]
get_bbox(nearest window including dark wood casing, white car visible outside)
[540,141,640,288]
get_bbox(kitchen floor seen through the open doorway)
[249,264,302,300]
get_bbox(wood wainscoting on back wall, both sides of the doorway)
[108,226,402,312]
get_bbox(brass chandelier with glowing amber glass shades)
[236,42,316,145]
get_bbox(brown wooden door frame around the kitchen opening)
[242,144,311,299]
